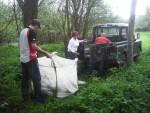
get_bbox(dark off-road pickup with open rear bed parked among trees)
[78,23,141,75]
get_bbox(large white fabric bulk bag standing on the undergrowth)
[38,55,78,98]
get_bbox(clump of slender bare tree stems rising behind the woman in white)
[57,0,97,53]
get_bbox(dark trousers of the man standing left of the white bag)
[21,59,42,98]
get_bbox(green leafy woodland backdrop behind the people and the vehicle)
[0,0,122,44]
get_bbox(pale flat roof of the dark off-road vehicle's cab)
[94,23,128,27]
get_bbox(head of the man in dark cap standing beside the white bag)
[29,19,41,32]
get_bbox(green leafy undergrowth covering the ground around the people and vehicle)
[0,32,150,113]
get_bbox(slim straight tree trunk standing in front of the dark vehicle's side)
[127,0,137,65]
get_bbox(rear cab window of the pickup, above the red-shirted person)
[95,27,119,37]
